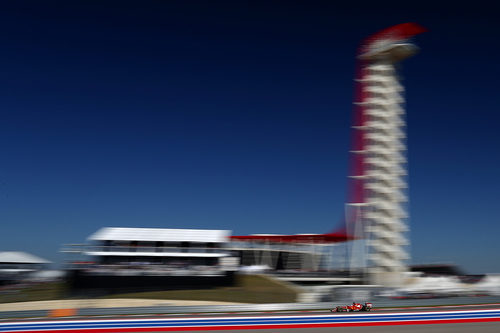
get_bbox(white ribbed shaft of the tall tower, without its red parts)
[363,59,409,284]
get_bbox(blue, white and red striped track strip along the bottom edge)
[0,305,500,333]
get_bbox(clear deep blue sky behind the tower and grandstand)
[0,1,500,273]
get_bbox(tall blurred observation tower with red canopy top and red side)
[346,23,425,285]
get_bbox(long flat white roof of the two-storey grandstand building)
[88,227,231,243]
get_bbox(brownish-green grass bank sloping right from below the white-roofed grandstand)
[99,275,297,303]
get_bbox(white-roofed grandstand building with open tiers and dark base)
[63,228,238,289]
